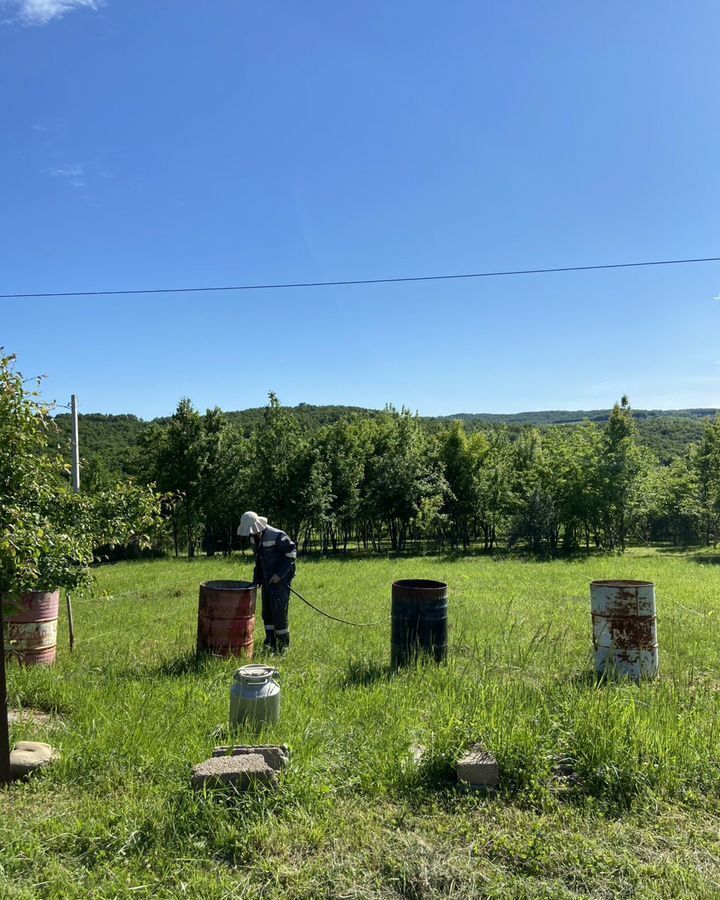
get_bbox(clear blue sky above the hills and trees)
[0,0,720,417]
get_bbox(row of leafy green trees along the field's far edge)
[91,394,720,556]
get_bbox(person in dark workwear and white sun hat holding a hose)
[238,512,297,653]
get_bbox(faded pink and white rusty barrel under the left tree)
[3,591,60,666]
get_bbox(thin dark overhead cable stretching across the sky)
[0,256,720,300]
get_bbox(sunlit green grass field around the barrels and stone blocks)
[0,550,720,900]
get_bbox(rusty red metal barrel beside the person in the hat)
[197,581,256,659]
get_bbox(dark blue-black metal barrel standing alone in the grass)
[391,579,447,669]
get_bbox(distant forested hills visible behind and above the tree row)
[55,403,720,475]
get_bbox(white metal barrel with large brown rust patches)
[590,581,658,681]
